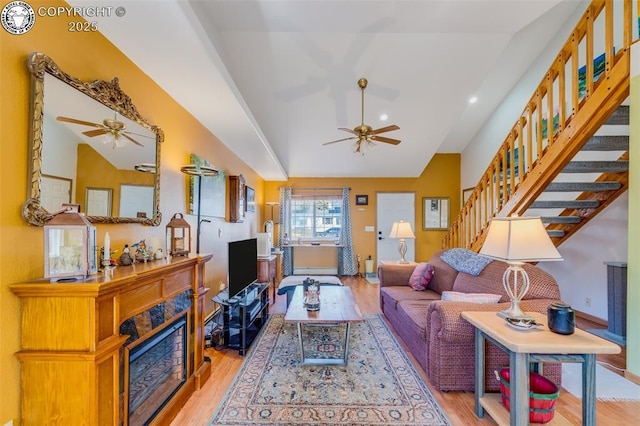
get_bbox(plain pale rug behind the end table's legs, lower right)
[562,363,640,401]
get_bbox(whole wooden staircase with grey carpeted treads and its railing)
[443,0,633,252]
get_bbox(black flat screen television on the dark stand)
[228,238,258,297]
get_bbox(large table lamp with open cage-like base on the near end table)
[479,216,562,318]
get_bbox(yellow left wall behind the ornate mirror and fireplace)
[0,1,264,424]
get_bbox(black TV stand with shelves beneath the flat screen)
[222,283,269,356]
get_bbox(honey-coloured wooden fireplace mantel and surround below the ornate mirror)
[10,254,212,425]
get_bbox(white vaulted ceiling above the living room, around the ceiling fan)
[69,0,582,180]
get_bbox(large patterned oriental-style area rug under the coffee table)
[209,315,450,426]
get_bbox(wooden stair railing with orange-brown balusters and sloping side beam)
[442,0,633,251]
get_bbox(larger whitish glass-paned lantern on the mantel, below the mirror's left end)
[44,204,98,281]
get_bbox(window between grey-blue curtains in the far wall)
[291,190,342,241]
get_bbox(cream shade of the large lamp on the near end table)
[480,216,562,263]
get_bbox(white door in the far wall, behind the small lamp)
[376,192,416,262]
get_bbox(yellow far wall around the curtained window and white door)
[262,154,462,262]
